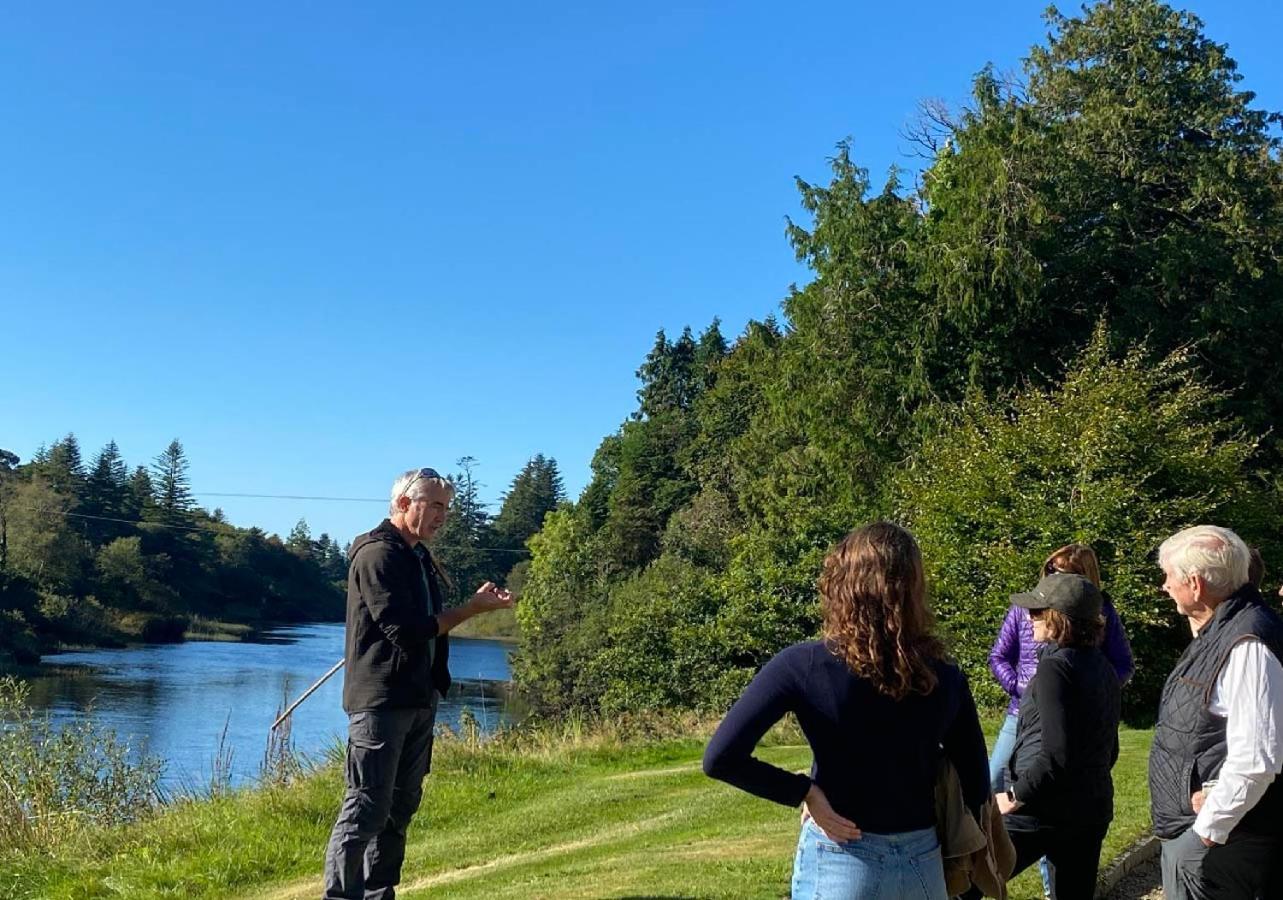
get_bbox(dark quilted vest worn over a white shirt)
[1150,584,1283,838]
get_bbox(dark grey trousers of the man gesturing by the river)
[323,705,436,900]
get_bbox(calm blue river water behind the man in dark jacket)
[22,623,511,790]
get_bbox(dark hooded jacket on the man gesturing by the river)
[343,519,450,713]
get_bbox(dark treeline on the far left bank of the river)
[0,434,346,662]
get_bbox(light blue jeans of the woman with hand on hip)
[792,819,948,900]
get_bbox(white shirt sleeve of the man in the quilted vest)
[1194,639,1283,844]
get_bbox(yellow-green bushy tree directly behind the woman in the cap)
[894,329,1283,705]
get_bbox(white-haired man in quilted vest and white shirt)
[1150,525,1283,900]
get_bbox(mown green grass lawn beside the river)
[0,731,1151,900]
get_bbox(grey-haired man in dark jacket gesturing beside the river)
[325,469,512,900]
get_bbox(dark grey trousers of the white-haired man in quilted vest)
[1162,828,1275,900]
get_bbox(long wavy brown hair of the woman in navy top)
[820,521,944,700]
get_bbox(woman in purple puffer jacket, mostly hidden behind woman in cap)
[989,544,1135,896]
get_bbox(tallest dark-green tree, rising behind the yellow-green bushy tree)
[916,0,1283,446]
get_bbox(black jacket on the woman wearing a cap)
[1007,645,1121,831]
